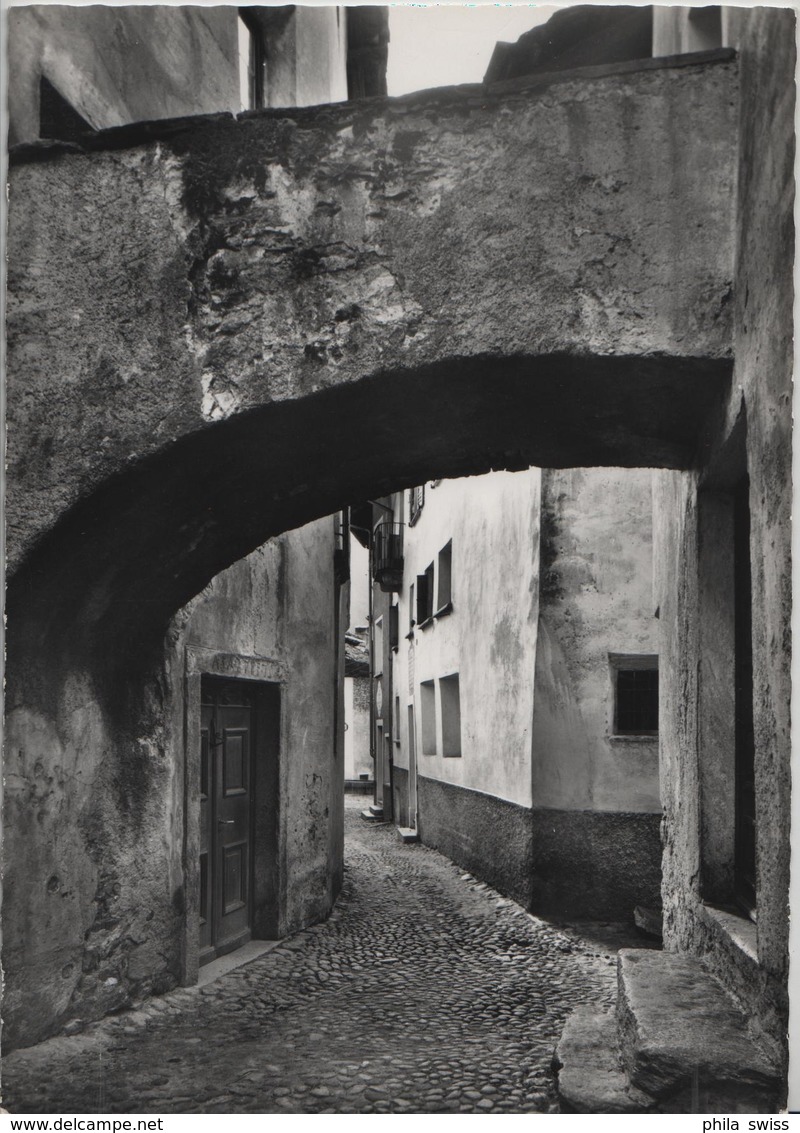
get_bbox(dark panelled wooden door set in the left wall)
[199,678,255,963]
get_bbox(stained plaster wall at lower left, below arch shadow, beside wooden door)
[3,661,185,1048]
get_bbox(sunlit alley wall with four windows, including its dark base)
[393,469,539,897]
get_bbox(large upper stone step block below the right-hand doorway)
[616,948,782,1114]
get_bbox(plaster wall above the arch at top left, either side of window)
[8,5,347,145]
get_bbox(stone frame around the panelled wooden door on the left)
[180,645,287,987]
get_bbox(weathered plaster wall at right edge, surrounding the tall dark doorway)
[656,8,795,1069]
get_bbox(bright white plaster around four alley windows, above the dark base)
[393,469,539,807]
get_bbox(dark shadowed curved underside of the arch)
[8,355,731,699]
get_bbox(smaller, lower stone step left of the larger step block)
[553,1007,655,1114]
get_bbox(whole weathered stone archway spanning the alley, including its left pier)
[6,52,735,1034]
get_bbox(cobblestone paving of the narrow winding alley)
[2,798,615,1114]
